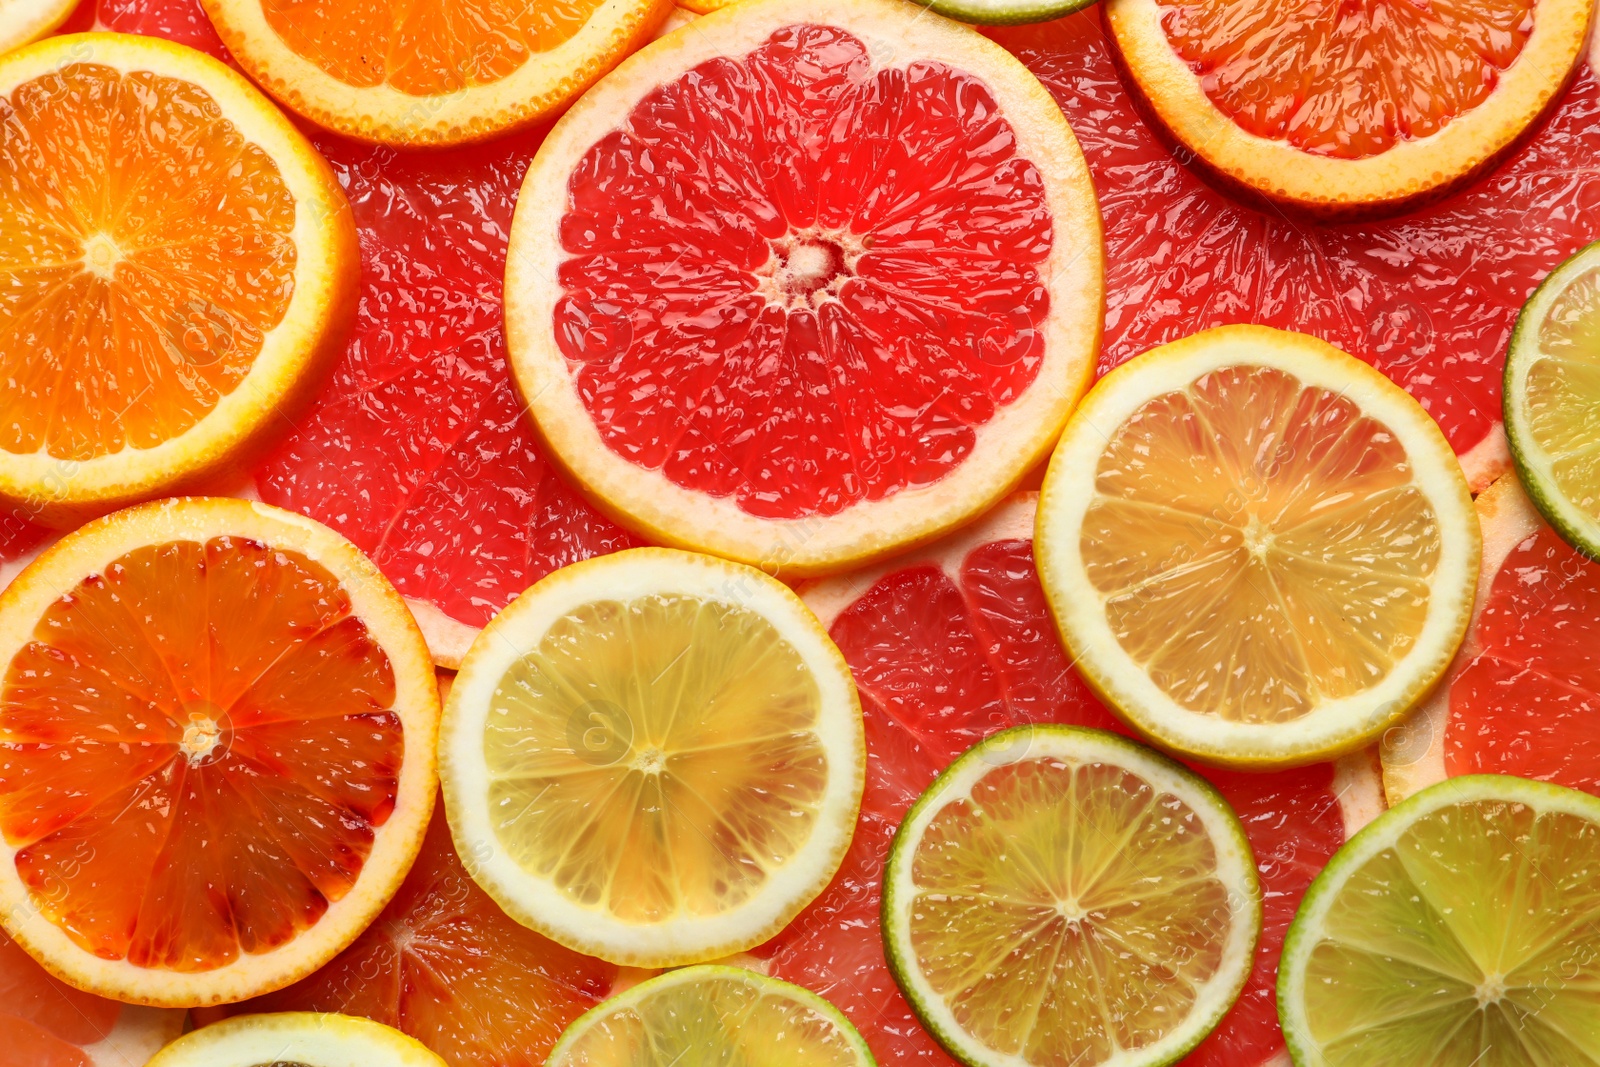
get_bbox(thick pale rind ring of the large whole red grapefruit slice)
[506,0,1104,577]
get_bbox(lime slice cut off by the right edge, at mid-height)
[1502,242,1600,560]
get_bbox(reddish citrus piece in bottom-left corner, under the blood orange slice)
[0,931,184,1067]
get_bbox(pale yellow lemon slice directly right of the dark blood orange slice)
[440,549,866,966]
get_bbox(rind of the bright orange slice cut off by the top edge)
[202,0,672,147]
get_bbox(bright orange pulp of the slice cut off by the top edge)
[261,0,600,96]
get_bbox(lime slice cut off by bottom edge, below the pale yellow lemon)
[546,966,874,1067]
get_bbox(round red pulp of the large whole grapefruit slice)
[555,26,1054,518]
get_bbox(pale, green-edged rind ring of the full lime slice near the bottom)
[882,725,1262,1067]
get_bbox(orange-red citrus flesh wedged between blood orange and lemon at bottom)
[222,803,618,1067]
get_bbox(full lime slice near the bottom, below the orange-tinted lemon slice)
[883,726,1261,1067]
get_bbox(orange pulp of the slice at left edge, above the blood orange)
[0,62,296,461]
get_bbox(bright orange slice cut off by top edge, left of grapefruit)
[202,0,672,146]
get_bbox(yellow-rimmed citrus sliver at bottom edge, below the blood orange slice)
[150,1013,445,1067]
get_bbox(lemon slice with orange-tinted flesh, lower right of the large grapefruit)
[1037,326,1478,768]
